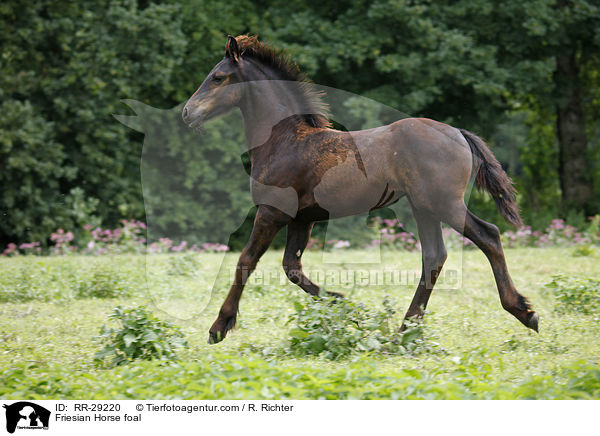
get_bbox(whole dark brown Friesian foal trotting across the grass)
[182,36,538,343]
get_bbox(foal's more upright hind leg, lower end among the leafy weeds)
[404,208,447,319]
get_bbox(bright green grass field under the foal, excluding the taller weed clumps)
[0,248,600,399]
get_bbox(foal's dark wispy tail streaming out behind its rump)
[459,129,523,227]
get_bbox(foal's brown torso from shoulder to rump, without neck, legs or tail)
[280,118,472,217]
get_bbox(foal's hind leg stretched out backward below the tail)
[444,202,539,332]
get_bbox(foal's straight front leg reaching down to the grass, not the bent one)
[208,205,291,344]
